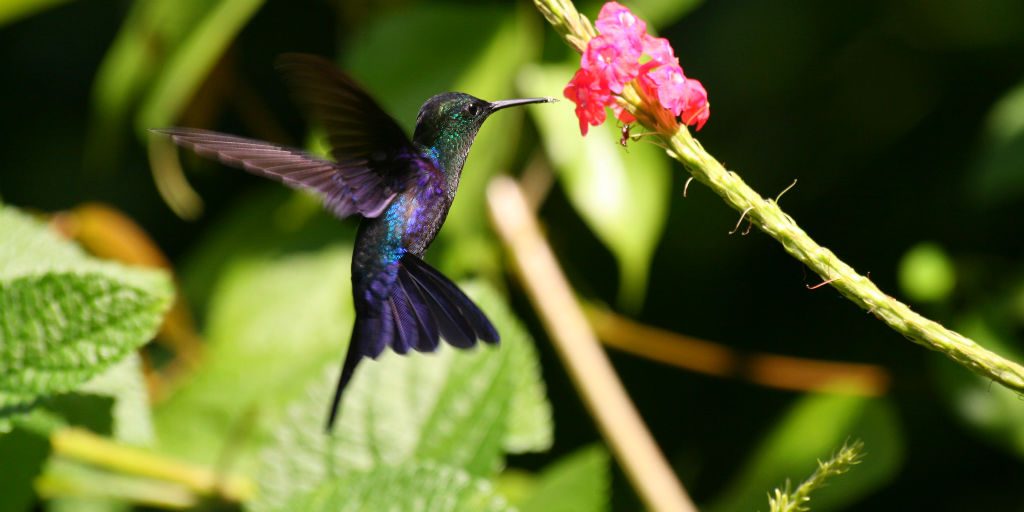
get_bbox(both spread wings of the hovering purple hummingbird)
[154,53,424,217]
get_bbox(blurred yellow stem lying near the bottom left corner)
[50,427,254,502]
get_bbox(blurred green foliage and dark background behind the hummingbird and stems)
[0,0,1024,512]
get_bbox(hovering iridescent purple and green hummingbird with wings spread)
[153,53,556,432]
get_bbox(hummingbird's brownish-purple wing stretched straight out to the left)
[153,128,397,217]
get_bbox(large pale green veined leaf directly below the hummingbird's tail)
[249,287,551,511]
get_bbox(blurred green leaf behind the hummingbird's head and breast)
[345,3,550,275]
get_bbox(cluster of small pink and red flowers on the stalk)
[564,2,711,135]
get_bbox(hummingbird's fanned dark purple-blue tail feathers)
[327,254,499,432]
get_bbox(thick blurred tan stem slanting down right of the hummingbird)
[487,177,696,512]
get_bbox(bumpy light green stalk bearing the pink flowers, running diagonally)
[535,0,1024,392]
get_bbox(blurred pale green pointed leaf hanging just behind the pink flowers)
[520,66,672,309]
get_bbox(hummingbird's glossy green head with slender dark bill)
[413,92,557,158]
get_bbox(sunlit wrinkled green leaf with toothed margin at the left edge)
[0,208,172,429]
